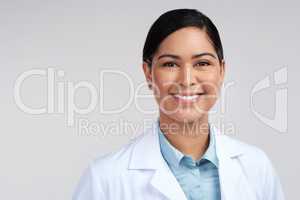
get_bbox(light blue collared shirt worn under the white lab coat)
[158,123,221,200]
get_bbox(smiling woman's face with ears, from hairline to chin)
[143,27,225,122]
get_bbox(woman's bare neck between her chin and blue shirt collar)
[159,115,209,160]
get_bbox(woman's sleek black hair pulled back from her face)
[143,9,223,66]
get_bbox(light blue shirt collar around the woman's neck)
[157,121,219,167]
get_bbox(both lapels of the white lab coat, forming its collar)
[128,121,255,200]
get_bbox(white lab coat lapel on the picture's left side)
[129,123,187,200]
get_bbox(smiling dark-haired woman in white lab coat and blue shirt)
[73,9,284,200]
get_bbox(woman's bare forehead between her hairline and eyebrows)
[156,27,216,56]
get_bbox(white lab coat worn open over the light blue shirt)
[73,123,284,200]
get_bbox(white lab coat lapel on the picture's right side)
[213,127,256,200]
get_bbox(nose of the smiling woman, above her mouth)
[179,65,196,88]
